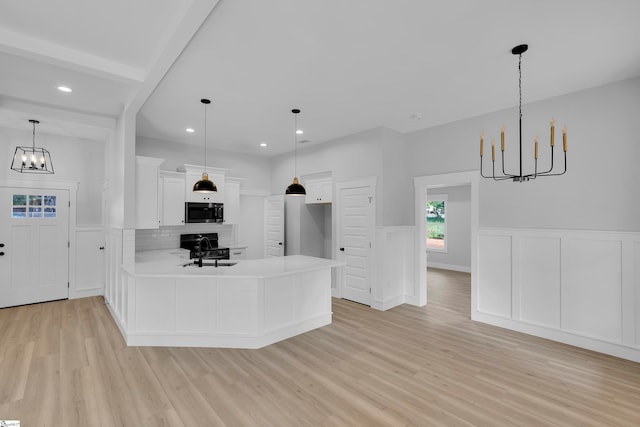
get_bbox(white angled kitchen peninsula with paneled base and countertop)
[110,250,342,348]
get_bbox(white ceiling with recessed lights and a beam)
[0,0,640,156]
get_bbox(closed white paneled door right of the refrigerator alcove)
[336,181,375,305]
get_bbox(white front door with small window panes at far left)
[0,187,69,307]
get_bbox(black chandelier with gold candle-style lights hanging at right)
[480,44,567,182]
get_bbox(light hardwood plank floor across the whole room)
[0,269,640,427]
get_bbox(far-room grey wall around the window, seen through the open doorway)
[427,185,471,272]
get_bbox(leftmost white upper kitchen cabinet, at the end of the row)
[136,156,164,229]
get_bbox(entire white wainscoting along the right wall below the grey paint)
[471,228,640,362]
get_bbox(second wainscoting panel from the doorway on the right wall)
[514,236,561,328]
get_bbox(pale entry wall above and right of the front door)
[0,128,104,225]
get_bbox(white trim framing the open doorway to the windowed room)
[416,170,480,307]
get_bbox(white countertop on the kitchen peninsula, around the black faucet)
[124,249,344,278]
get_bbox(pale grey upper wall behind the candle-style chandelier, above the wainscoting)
[406,78,640,231]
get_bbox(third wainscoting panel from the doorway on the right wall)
[562,238,622,342]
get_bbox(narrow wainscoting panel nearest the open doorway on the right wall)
[477,234,512,318]
